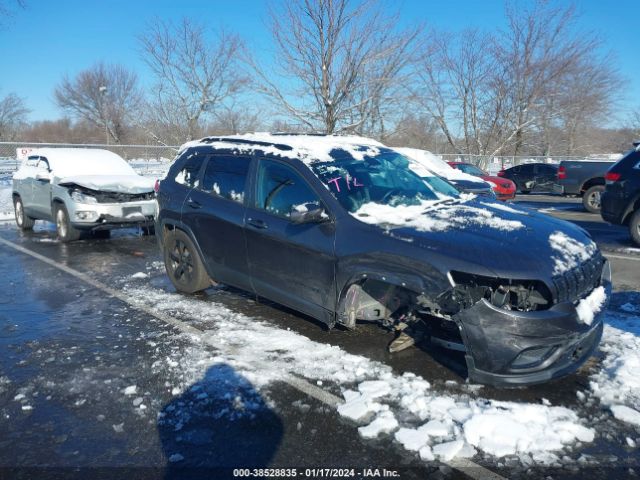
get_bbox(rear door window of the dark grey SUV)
[202,155,251,203]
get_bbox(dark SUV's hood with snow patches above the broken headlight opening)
[370,201,597,282]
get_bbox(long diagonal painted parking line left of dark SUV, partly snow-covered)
[0,237,506,480]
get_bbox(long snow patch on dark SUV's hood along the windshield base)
[351,200,524,232]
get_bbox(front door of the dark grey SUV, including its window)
[246,159,336,319]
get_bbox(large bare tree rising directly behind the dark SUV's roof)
[250,0,419,133]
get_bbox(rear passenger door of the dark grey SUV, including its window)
[182,153,252,290]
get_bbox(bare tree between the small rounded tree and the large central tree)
[139,18,248,143]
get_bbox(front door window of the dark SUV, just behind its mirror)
[255,160,320,217]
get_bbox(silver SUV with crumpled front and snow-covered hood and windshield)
[13,148,157,242]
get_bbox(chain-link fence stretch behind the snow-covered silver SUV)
[0,142,180,178]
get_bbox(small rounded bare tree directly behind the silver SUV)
[54,63,142,143]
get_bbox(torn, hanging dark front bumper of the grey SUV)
[454,262,611,386]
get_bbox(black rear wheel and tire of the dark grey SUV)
[163,230,211,293]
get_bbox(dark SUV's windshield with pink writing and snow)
[311,149,458,212]
